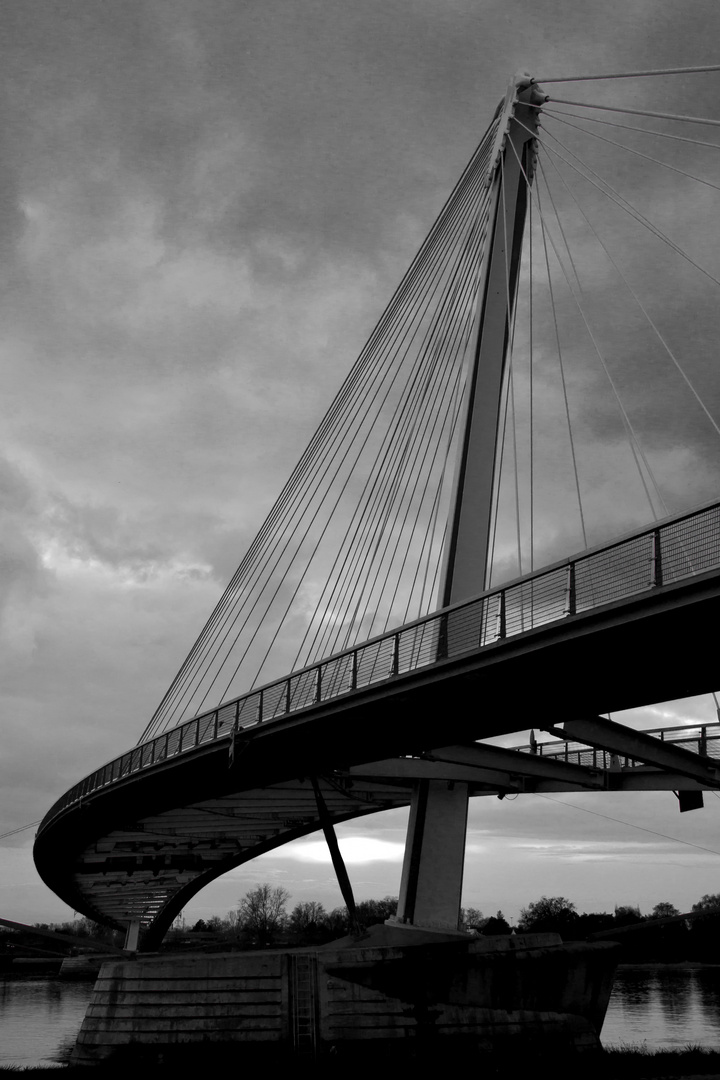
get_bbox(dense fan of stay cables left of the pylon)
[140,107,498,741]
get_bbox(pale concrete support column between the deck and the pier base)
[393,780,467,933]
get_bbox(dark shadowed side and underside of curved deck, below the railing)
[36,569,720,947]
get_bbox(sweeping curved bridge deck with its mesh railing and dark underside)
[36,504,720,934]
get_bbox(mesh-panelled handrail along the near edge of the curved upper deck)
[39,494,720,832]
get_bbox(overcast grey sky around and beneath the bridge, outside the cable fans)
[0,0,720,921]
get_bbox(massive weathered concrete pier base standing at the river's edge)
[72,927,617,1064]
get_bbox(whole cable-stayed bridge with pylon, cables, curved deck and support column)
[36,71,720,944]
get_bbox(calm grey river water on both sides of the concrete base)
[0,967,720,1066]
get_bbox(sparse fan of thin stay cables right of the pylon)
[491,65,720,583]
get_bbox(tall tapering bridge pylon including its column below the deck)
[391,75,546,933]
